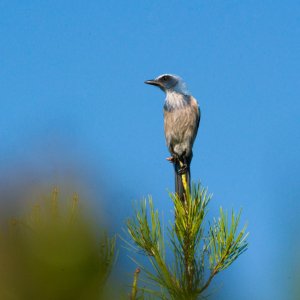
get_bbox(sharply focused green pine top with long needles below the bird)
[127,185,248,300]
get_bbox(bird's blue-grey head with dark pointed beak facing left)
[145,74,188,95]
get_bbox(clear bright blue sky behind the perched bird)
[0,0,300,300]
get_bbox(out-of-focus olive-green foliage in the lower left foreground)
[0,189,115,300]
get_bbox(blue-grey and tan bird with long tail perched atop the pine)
[145,74,201,202]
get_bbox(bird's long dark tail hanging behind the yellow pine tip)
[174,160,191,202]
